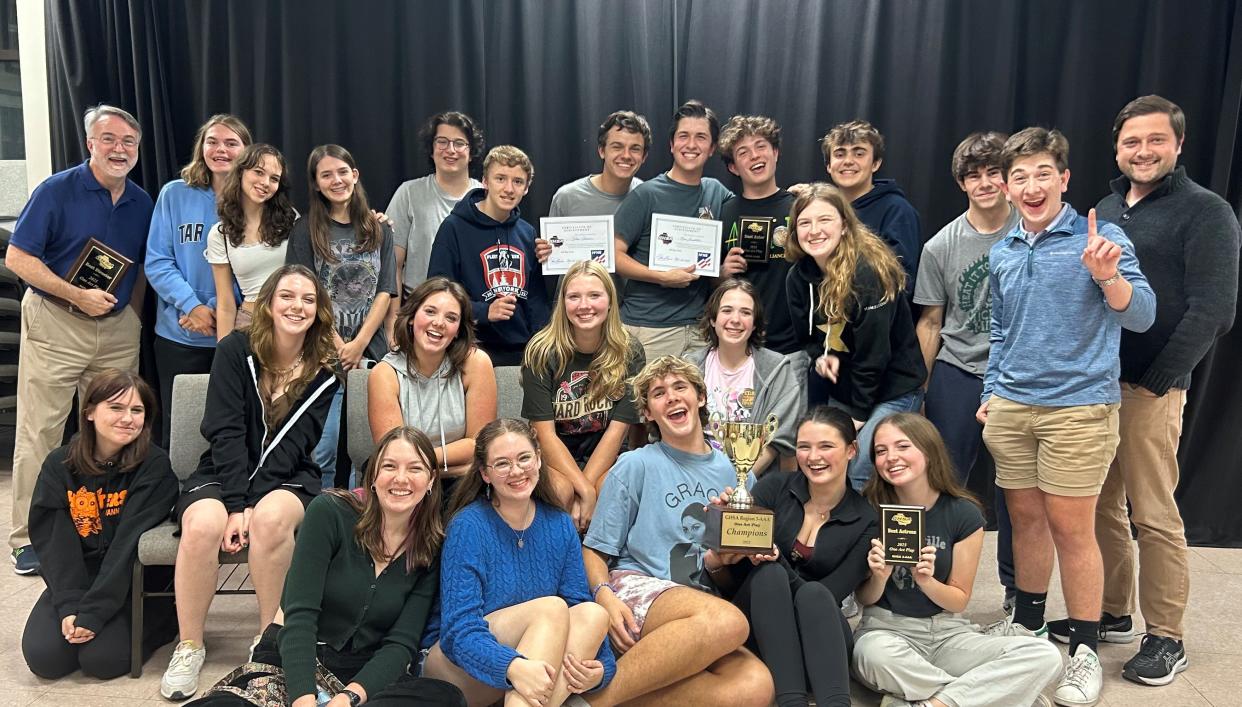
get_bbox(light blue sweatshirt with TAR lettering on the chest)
[145,179,220,348]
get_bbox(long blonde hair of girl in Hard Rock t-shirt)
[522,260,637,405]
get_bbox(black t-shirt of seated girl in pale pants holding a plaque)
[876,495,984,619]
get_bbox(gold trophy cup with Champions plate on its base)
[704,415,776,554]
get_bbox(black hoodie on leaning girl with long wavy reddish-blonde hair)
[785,257,927,420]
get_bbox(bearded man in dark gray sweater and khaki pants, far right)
[1048,96,1240,685]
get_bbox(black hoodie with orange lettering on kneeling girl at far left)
[30,445,178,632]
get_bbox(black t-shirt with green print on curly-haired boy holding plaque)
[720,189,801,354]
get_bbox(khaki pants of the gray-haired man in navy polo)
[9,291,139,548]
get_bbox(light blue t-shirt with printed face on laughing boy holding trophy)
[582,442,755,591]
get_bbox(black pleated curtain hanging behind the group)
[46,0,1242,547]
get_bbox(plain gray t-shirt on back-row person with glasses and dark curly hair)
[385,174,483,288]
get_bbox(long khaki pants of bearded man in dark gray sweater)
[1095,383,1190,640]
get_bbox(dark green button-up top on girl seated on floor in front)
[279,495,440,700]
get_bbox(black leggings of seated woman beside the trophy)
[733,562,853,707]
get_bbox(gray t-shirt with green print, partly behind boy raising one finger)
[914,209,1018,378]
